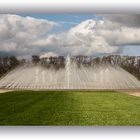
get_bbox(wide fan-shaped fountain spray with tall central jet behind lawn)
[0,56,140,90]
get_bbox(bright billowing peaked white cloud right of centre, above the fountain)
[34,20,118,55]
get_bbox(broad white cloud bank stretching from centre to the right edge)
[35,17,140,55]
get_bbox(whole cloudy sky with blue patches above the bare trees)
[0,14,140,58]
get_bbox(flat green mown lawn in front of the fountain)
[0,91,140,126]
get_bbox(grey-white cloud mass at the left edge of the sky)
[0,15,56,55]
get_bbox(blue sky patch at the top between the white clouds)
[19,14,102,32]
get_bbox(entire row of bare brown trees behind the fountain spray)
[0,55,140,80]
